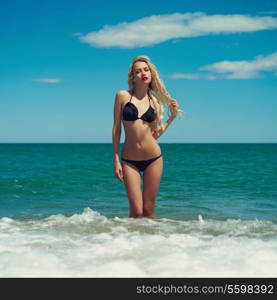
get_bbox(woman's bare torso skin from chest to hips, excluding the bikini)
[121,91,161,160]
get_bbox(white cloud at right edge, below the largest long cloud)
[171,52,277,80]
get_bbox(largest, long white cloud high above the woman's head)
[78,12,277,48]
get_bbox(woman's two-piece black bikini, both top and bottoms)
[122,91,162,172]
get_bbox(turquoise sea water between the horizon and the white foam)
[0,144,277,221]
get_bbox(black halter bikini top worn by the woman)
[122,95,156,123]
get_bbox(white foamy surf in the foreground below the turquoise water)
[0,208,277,277]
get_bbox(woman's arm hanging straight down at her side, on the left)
[112,91,123,182]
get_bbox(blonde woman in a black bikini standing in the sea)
[112,56,182,218]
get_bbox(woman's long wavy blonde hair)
[128,55,183,128]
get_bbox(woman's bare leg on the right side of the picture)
[142,156,163,218]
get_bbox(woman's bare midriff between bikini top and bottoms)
[121,119,161,160]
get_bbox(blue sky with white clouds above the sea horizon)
[0,0,277,143]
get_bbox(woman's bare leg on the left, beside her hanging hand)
[122,161,143,218]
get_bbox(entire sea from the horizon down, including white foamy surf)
[0,144,277,277]
